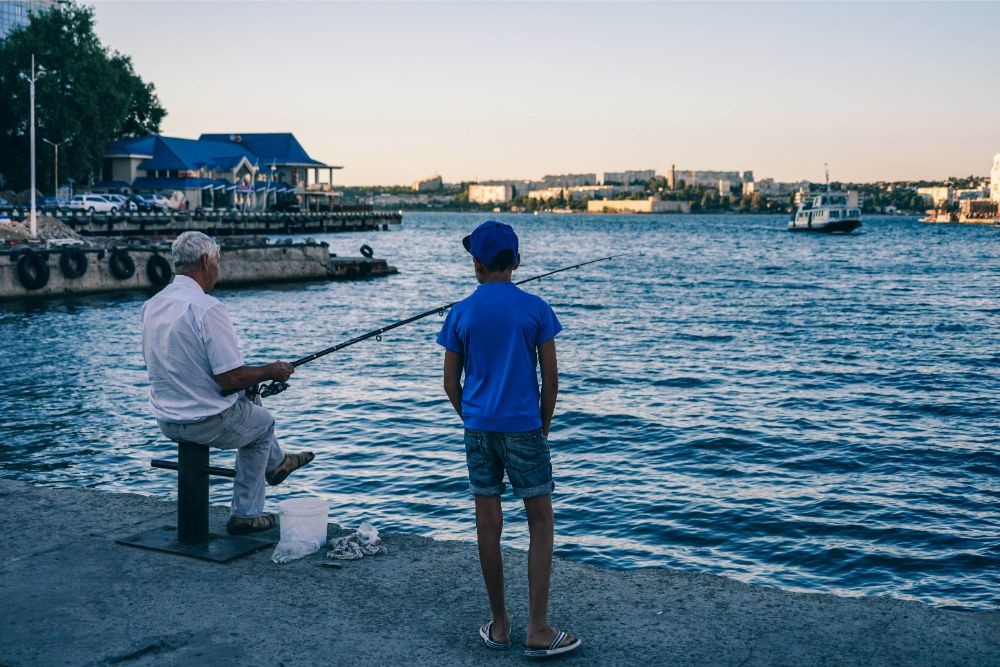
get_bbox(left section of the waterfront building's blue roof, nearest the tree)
[105,135,258,171]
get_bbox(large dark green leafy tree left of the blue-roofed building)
[0,4,166,190]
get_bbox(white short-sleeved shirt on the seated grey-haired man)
[142,275,243,424]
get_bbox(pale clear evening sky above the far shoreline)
[93,0,1000,185]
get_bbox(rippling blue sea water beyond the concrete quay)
[0,213,1000,609]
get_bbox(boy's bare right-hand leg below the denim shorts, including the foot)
[524,495,575,648]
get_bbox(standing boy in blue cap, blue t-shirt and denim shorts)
[437,220,581,657]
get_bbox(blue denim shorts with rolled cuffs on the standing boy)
[465,428,556,498]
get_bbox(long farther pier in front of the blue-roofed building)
[0,205,403,236]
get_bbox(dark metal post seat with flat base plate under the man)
[117,441,276,563]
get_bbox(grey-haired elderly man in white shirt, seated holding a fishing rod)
[142,232,313,535]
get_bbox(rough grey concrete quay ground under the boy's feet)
[0,479,1000,667]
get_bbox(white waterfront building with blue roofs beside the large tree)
[103,133,342,210]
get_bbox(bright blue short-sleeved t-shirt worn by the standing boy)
[437,282,562,433]
